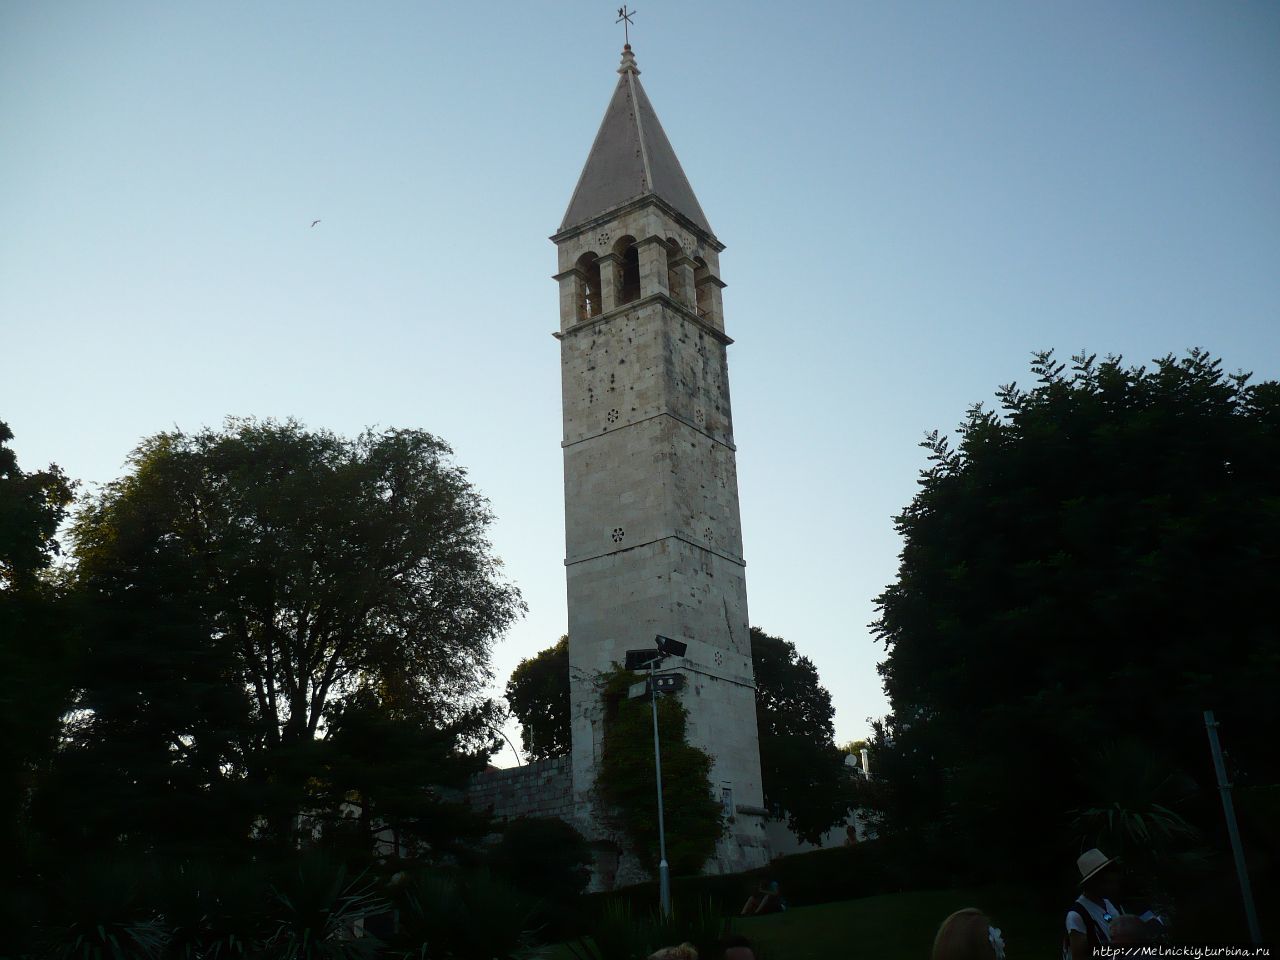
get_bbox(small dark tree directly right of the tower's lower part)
[751,627,852,842]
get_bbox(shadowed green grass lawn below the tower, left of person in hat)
[548,887,1061,960]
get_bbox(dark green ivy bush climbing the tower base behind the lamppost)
[595,667,724,874]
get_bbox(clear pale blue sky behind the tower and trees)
[0,0,1280,762]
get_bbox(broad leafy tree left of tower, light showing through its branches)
[46,420,522,845]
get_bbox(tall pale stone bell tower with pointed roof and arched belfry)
[552,44,768,886]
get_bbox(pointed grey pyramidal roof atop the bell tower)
[559,44,714,236]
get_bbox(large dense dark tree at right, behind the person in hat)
[873,351,1280,890]
